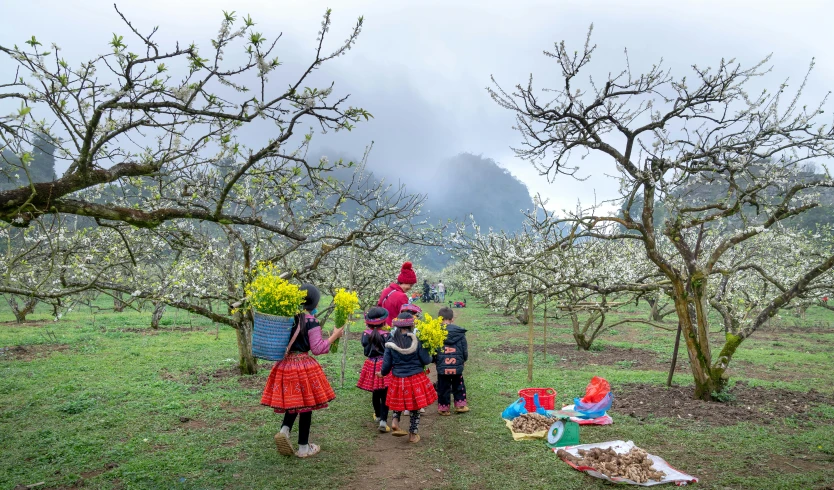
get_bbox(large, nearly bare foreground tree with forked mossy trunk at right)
[489,27,834,400]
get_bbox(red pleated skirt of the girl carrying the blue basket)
[261,352,336,413]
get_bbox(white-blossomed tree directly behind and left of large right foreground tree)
[448,215,669,350]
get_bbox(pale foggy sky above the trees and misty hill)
[0,0,834,209]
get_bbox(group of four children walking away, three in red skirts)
[261,264,469,458]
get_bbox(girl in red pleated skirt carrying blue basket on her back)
[261,284,344,458]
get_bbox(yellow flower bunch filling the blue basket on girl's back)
[244,262,307,316]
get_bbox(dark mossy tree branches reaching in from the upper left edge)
[0,10,371,226]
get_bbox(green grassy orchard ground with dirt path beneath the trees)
[0,292,834,489]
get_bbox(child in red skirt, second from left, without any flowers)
[356,306,391,432]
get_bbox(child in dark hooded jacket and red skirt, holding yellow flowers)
[377,313,437,442]
